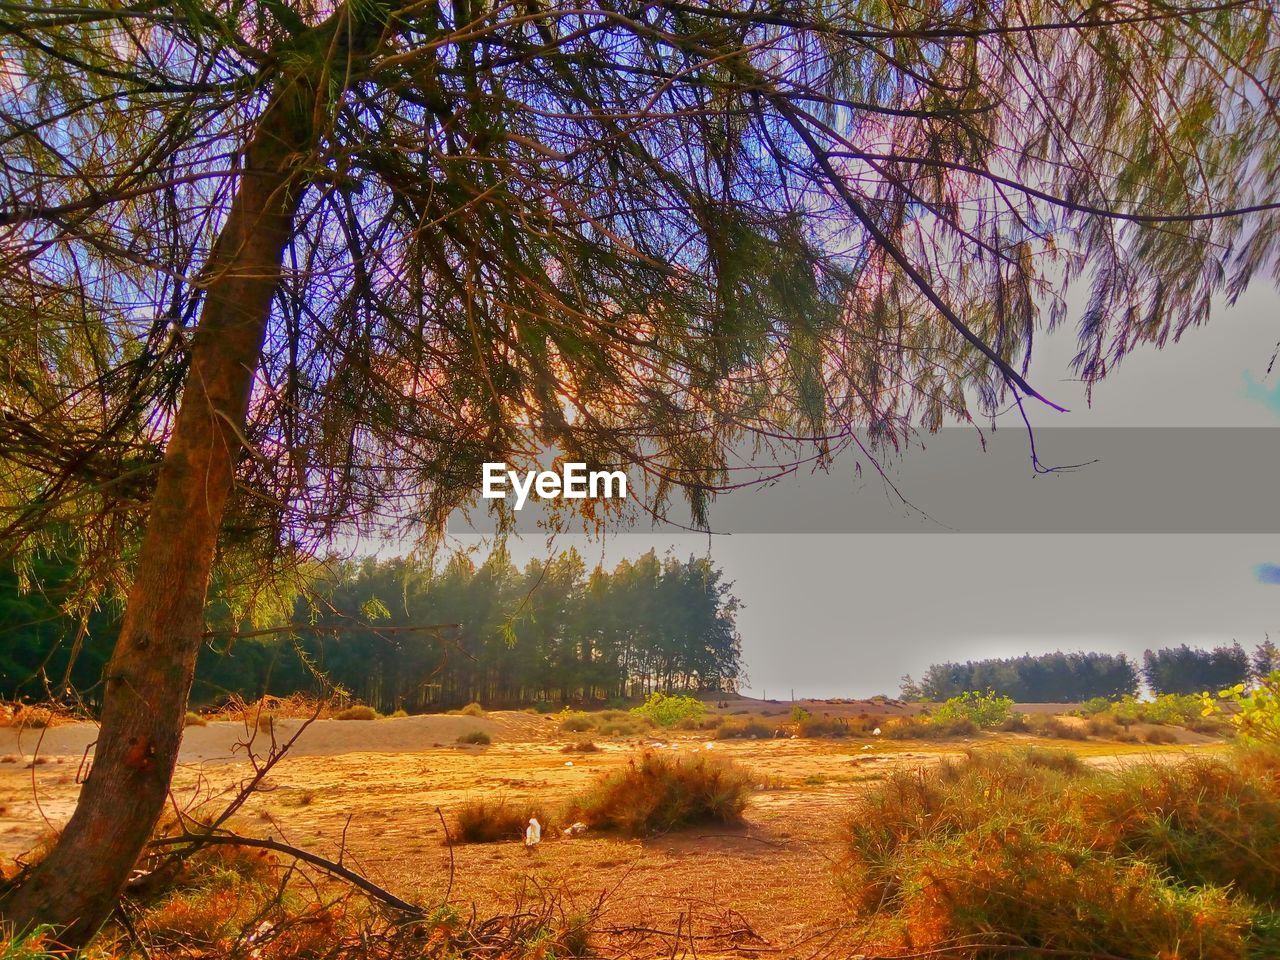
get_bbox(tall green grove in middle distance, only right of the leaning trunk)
[185,549,741,713]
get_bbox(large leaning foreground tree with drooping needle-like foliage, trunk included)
[0,0,1277,943]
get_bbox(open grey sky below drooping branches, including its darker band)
[394,284,1280,699]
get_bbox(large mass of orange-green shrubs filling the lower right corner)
[842,749,1280,960]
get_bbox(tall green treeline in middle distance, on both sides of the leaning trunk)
[0,549,742,712]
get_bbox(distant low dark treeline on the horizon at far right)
[902,639,1280,703]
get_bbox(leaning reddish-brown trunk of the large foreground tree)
[0,73,316,946]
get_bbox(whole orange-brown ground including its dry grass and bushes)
[0,703,1259,960]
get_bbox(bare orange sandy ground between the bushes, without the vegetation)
[0,704,1223,957]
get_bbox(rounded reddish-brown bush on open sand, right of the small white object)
[568,753,753,837]
